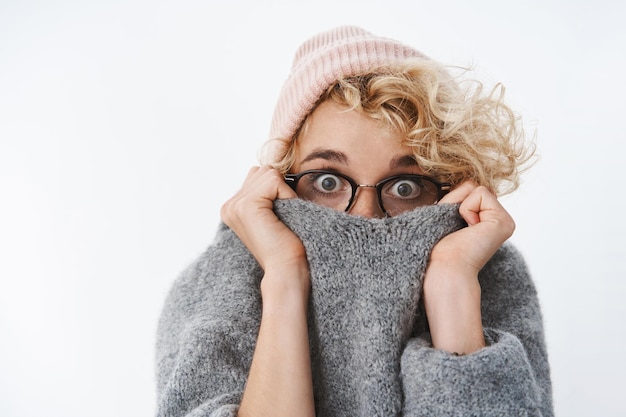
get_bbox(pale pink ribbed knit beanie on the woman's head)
[270,26,426,139]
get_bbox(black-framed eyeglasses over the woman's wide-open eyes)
[285,169,451,216]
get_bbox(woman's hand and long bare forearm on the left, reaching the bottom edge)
[221,167,315,417]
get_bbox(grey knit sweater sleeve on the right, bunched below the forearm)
[401,244,553,417]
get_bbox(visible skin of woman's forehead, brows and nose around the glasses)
[291,101,422,218]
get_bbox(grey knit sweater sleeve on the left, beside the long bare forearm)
[156,229,260,417]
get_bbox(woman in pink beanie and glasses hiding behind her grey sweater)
[157,27,553,417]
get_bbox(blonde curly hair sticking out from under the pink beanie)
[261,60,535,195]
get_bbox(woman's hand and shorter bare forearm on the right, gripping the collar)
[424,182,515,354]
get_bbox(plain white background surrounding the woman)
[0,0,626,417]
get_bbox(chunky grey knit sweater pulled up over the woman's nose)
[157,200,553,417]
